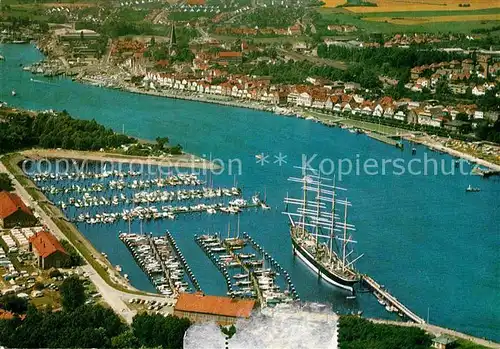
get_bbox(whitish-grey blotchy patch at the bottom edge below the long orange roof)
[184,303,338,349]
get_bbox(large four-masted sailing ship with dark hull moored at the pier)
[283,167,363,293]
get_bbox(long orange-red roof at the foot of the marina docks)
[175,293,255,317]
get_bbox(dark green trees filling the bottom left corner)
[0,276,190,348]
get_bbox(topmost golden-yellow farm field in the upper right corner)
[324,0,500,13]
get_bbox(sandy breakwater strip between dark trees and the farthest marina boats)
[20,149,219,170]
